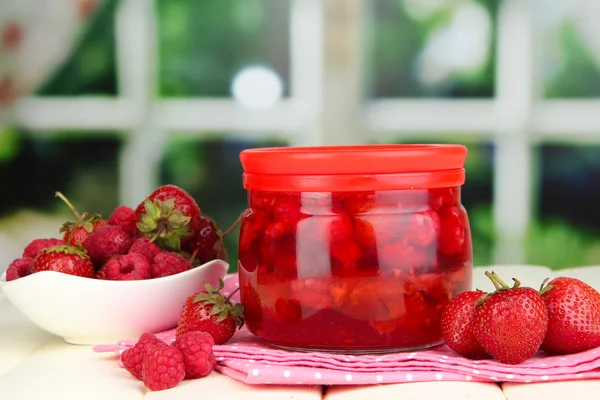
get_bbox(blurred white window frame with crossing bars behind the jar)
[4,0,600,263]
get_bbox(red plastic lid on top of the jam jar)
[240,144,467,192]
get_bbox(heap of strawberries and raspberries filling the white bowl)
[6,185,227,281]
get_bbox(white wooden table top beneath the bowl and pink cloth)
[0,266,600,400]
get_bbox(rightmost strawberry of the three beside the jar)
[540,277,600,354]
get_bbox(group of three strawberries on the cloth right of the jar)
[442,272,600,364]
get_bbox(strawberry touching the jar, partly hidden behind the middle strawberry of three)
[441,290,489,360]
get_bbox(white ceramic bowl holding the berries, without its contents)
[0,260,229,345]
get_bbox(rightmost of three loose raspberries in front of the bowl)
[173,331,217,379]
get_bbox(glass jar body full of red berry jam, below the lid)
[239,188,472,350]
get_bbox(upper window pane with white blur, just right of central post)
[369,0,497,97]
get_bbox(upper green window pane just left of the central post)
[157,0,290,97]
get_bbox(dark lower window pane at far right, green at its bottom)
[528,144,600,268]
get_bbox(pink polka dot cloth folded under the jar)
[94,276,600,385]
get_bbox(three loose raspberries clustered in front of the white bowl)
[121,332,217,391]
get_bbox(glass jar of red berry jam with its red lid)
[238,145,472,353]
